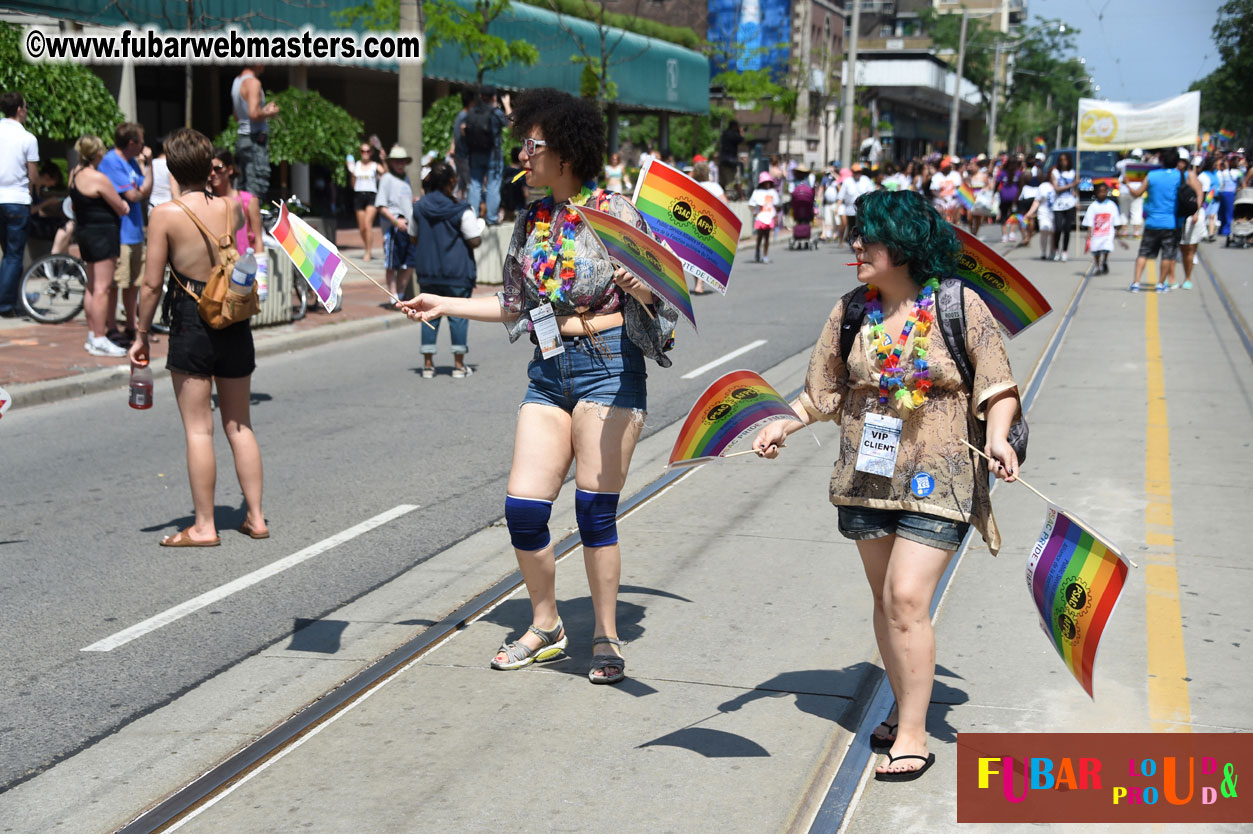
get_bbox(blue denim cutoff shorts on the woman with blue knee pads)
[523,327,648,413]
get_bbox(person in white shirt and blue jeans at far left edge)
[0,93,39,318]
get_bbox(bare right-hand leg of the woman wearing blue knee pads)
[574,402,644,677]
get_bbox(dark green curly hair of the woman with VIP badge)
[856,192,961,287]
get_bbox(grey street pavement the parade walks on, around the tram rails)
[0,229,1253,834]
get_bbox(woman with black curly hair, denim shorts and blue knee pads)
[401,88,678,684]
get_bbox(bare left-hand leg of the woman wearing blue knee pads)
[496,403,574,661]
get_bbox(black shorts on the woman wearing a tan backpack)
[165,282,257,379]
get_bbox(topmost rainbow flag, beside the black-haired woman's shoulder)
[633,159,741,296]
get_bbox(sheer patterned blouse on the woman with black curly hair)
[497,193,679,368]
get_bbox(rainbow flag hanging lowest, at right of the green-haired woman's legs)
[1026,502,1130,698]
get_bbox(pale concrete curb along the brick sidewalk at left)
[8,310,410,407]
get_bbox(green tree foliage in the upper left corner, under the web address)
[0,21,124,145]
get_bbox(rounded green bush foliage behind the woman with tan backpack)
[213,88,365,185]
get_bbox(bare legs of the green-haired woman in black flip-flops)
[857,536,954,773]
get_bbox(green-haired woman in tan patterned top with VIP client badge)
[753,192,1019,781]
